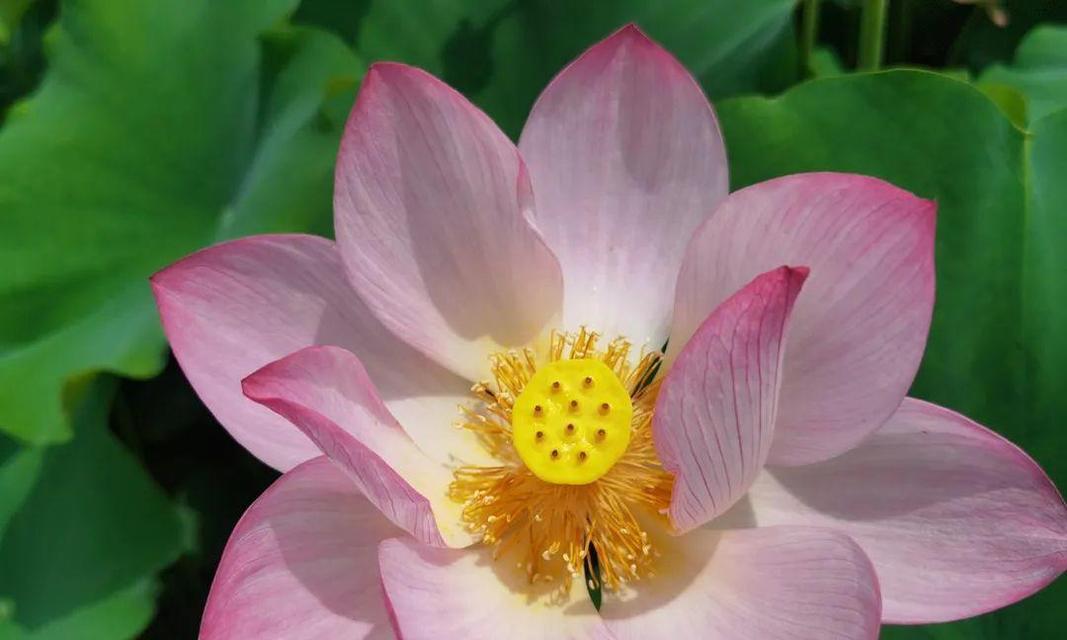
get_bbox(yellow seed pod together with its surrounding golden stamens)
[449,329,671,592]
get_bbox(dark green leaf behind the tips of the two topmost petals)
[337,0,798,135]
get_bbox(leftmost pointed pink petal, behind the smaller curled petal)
[152,236,482,470]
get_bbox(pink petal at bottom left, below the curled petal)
[200,458,399,640]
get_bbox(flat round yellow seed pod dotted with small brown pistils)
[511,358,634,484]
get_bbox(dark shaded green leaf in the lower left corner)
[0,379,182,640]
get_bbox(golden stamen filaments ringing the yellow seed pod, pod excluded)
[449,329,671,590]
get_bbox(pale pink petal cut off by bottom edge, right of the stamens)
[601,527,880,640]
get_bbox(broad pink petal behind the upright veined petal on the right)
[670,174,935,465]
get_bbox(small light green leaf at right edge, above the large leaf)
[980,27,1067,122]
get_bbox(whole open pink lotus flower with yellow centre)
[153,27,1067,640]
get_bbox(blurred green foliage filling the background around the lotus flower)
[0,0,1067,640]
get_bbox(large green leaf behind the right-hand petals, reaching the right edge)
[718,70,1067,639]
